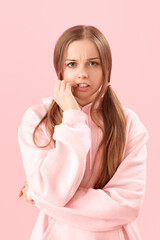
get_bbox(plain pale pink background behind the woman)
[0,0,160,240]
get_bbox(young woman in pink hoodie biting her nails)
[18,25,148,240]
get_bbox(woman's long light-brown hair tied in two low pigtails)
[33,25,126,189]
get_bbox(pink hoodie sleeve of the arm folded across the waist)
[31,111,148,231]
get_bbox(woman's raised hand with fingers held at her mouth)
[53,80,81,111]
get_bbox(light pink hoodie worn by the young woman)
[18,97,148,240]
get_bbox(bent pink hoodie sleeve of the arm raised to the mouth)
[18,106,91,206]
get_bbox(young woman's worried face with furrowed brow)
[63,39,103,106]
